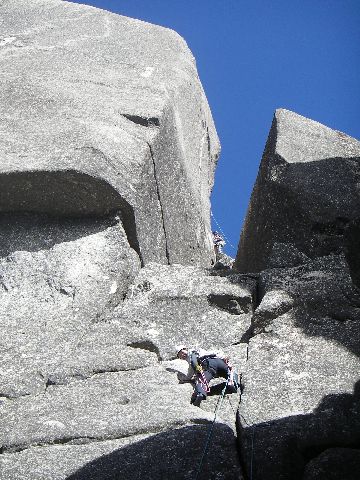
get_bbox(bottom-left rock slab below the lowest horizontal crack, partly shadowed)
[0,424,242,480]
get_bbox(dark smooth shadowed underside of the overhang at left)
[0,170,141,256]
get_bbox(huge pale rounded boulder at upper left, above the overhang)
[0,0,219,265]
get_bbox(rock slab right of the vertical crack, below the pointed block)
[239,256,360,480]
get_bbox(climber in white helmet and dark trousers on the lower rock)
[176,346,239,407]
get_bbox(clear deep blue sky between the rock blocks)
[69,0,360,256]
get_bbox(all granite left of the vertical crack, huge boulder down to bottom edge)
[0,0,250,480]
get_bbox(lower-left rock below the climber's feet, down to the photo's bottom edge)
[0,366,241,480]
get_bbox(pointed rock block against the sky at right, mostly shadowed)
[235,110,360,279]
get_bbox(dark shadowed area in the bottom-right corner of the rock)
[238,382,360,480]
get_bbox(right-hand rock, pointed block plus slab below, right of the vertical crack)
[236,110,360,480]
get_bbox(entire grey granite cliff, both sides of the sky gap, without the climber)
[0,0,360,480]
